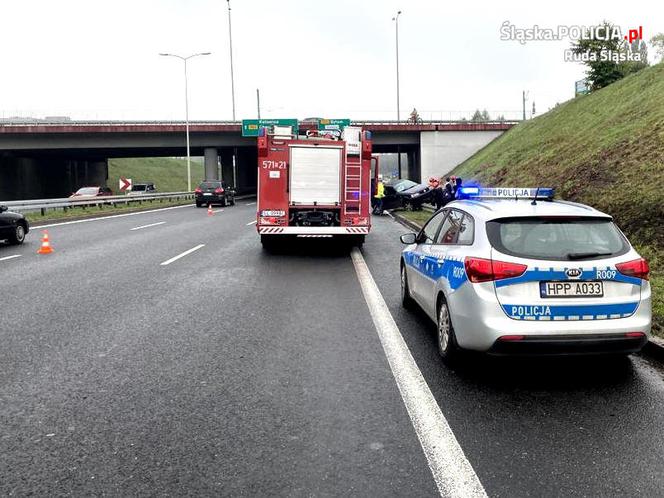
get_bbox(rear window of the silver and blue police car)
[487,217,629,261]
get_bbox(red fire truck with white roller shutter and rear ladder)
[256,126,378,248]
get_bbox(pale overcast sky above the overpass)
[0,0,664,120]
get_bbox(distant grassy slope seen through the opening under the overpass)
[108,157,203,192]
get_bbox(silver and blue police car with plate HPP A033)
[401,187,651,361]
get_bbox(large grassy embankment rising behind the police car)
[453,64,664,334]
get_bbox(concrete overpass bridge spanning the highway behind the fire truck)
[0,121,516,200]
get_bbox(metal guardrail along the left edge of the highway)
[0,192,194,215]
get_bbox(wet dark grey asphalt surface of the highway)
[0,201,664,496]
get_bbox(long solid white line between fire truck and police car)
[351,248,487,497]
